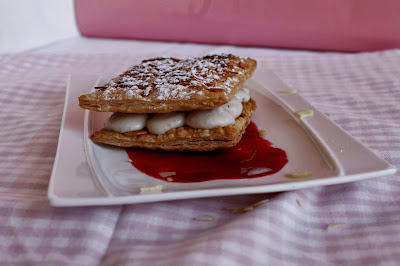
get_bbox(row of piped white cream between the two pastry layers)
[104,88,250,135]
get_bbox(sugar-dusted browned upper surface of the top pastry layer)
[97,54,245,101]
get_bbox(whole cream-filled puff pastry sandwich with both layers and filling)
[79,54,257,151]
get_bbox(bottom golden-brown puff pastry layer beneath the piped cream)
[91,99,256,151]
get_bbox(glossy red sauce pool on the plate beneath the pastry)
[127,123,288,183]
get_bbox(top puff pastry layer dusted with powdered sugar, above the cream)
[79,54,257,113]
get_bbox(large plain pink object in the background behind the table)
[75,0,400,51]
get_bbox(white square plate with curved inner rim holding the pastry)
[48,71,396,206]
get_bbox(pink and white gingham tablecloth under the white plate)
[0,38,400,265]
